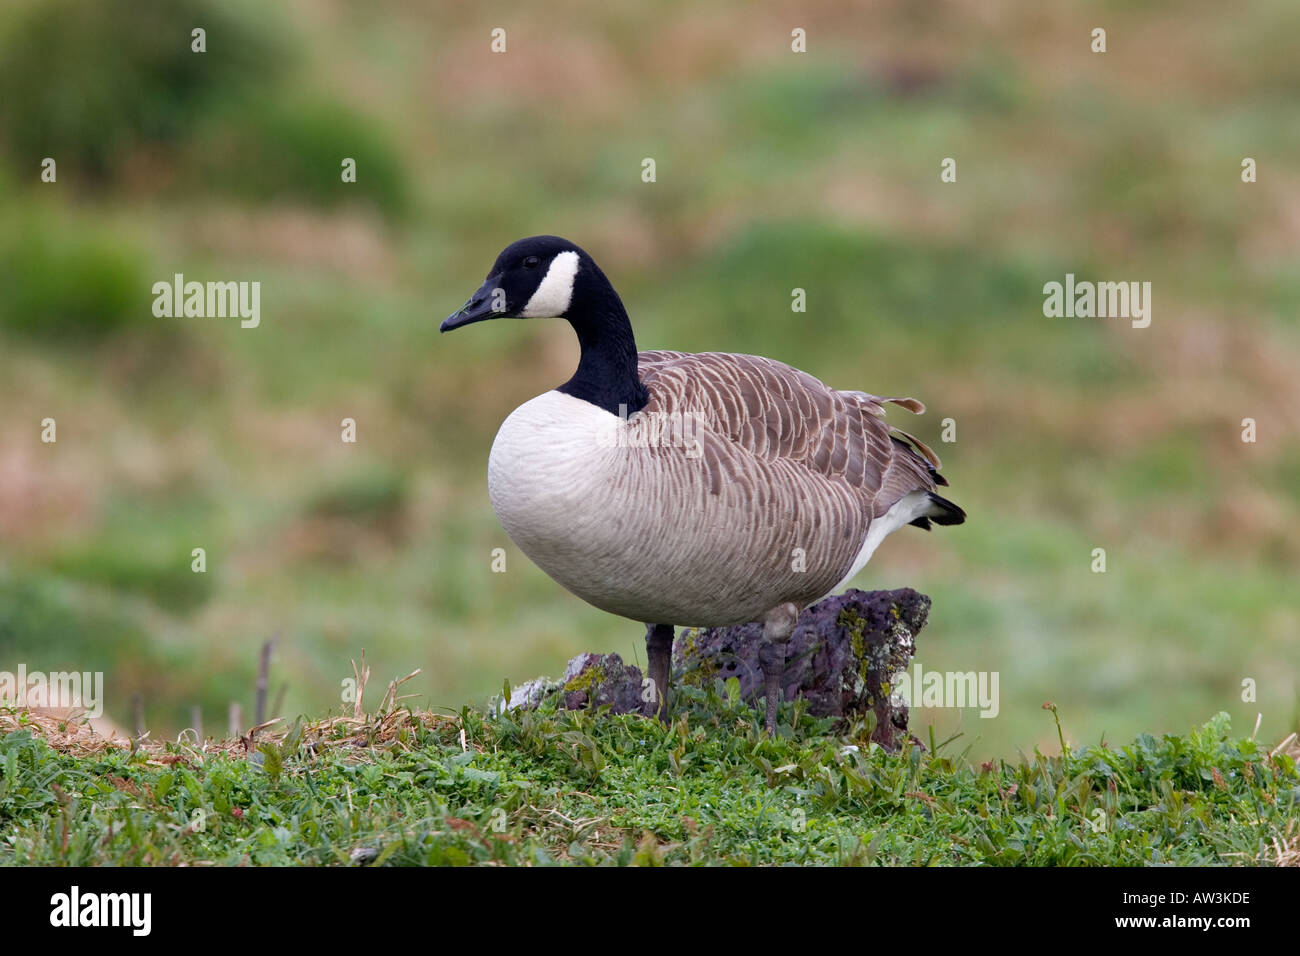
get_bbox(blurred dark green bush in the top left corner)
[0,0,286,179]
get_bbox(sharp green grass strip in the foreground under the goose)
[0,702,1300,866]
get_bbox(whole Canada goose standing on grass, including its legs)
[441,235,966,734]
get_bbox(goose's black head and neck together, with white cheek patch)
[441,235,649,415]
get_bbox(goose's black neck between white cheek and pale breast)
[558,259,650,415]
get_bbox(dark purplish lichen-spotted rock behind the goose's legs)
[510,588,930,750]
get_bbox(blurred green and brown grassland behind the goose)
[0,0,1300,756]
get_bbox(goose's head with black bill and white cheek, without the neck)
[441,235,590,332]
